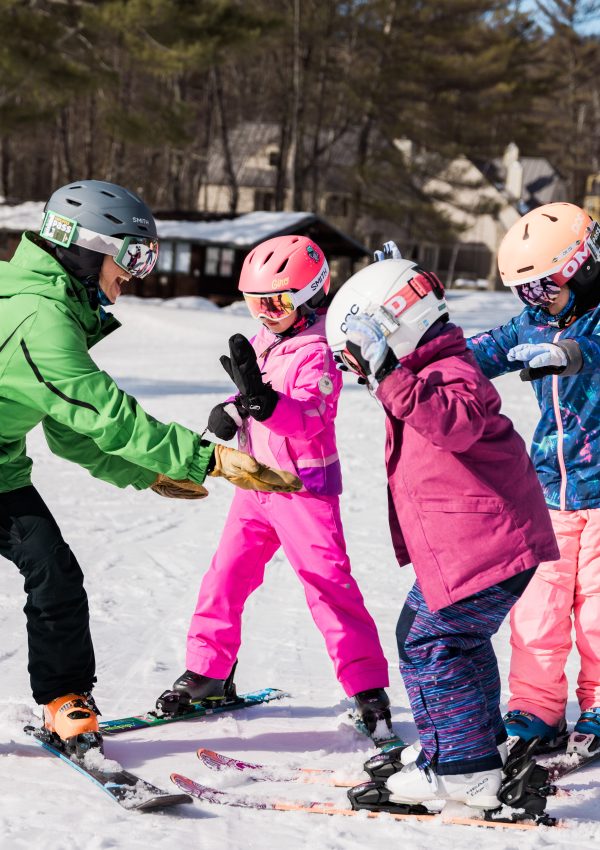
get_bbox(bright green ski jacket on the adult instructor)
[0,233,213,492]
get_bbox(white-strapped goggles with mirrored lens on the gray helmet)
[40,210,158,277]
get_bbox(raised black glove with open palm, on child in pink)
[220,334,279,422]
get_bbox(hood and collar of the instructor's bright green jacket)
[0,232,120,345]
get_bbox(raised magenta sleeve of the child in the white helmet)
[377,357,487,452]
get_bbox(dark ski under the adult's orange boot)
[25,726,192,812]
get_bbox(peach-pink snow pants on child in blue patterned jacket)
[508,509,600,725]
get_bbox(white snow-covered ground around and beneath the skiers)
[0,291,600,850]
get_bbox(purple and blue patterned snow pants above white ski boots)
[396,569,535,774]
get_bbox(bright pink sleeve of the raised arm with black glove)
[263,346,342,439]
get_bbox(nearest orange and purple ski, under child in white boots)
[171,773,556,829]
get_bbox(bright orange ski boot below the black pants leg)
[44,694,102,756]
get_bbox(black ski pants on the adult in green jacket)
[0,487,96,704]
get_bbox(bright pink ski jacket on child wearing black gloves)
[239,316,342,496]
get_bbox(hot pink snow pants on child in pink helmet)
[186,490,389,696]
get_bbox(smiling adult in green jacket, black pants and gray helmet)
[0,180,300,753]
